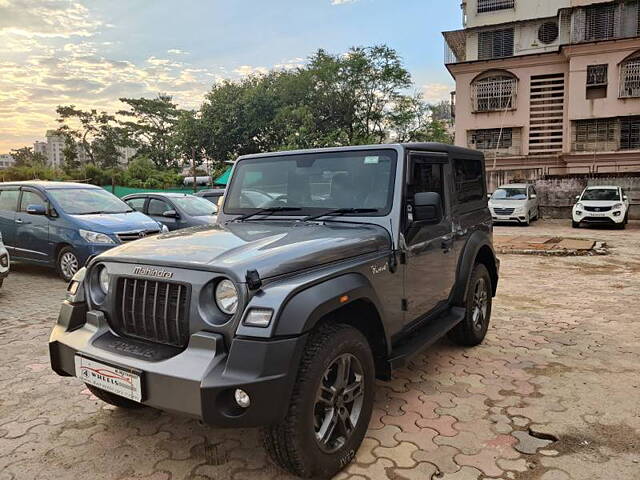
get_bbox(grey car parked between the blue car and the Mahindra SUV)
[122,193,218,231]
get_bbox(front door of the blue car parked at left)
[15,188,53,262]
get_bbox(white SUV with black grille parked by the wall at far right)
[572,186,629,228]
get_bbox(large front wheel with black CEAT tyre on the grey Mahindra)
[263,324,375,478]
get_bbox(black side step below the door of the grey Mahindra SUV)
[389,307,466,370]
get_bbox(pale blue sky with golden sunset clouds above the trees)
[0,0,461,153]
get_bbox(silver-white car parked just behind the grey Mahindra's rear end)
[489,183,540,225]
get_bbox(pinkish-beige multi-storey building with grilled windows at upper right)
[444,0,640,182]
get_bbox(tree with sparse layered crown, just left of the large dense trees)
[118,94,182,168]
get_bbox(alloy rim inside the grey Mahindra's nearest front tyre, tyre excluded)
[313,353,364,454]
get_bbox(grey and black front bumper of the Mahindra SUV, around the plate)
[49,302,306,427]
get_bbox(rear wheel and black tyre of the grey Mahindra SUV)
[449,263,493,347]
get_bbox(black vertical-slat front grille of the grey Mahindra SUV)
[111,277,190,347]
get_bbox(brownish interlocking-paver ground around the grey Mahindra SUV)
[0,222,640,480]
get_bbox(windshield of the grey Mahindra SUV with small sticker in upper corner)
[224,150,397,216]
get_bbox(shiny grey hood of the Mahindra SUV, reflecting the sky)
[101,221,391,278]
